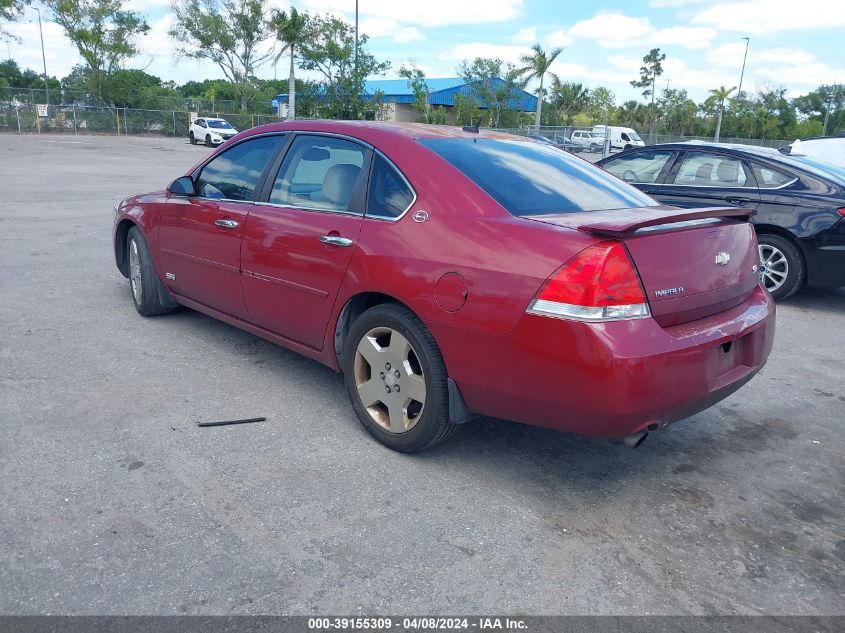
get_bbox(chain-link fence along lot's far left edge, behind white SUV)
[0,102,279,138]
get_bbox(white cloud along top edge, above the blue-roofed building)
[296,0,524,27]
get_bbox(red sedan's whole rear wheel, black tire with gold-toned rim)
[342,303,460,453]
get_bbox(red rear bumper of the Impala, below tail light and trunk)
[435,286,775,437]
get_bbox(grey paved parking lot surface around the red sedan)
[0,135,845,614]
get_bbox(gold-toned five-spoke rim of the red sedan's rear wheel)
[354,327,425,433]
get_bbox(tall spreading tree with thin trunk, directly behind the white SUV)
[169,0,275,111]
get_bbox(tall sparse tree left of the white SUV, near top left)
[43,0,150,97]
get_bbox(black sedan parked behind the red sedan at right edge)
[597,142,845,299]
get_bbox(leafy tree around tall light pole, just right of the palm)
[299,14,390,119]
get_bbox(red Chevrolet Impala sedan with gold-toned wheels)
[114,121,775,452]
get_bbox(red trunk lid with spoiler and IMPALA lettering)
[531,206,759,327]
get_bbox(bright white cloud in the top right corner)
[692,0,845,34]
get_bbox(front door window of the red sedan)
[197,136,281,202]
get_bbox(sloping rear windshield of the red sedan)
[420,138,658,216]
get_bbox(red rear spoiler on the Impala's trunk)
[572,206,757,239]
